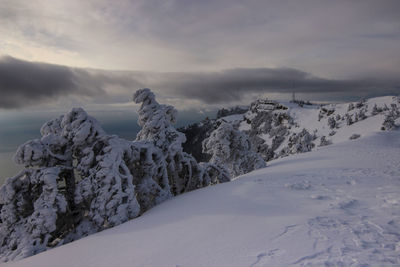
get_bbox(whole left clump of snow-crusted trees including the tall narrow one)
[0,89,230,261]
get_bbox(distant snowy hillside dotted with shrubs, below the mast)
[179,96,400,161]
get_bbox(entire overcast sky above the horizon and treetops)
[0,0,400,110]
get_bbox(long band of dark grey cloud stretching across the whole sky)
[0,57,400,109]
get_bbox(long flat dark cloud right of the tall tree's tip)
[148,68,400,104]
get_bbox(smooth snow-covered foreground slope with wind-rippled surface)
[5,128,400,267]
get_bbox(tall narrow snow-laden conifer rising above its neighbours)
[133,88,230,195]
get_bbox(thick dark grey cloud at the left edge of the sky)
[0,57,102,108]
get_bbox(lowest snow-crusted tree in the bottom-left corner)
[0,167,71,261]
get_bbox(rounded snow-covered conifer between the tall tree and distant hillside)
[203,121,266,177]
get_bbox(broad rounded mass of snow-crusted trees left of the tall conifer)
[0,108,148,261]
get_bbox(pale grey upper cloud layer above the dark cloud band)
[0,0,400,78]
